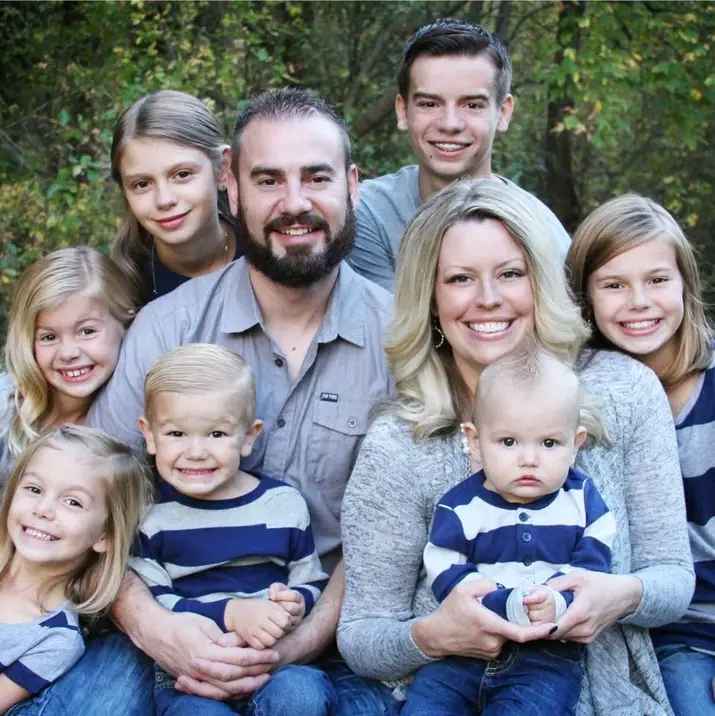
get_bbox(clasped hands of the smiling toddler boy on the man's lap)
[224,599,293,649]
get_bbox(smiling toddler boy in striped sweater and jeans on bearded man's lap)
[131,343,334,716]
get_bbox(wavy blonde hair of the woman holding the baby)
[385,177,589,438]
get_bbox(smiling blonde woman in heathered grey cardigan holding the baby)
[338,179,693,715]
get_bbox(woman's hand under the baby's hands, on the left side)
[412,580,554,659]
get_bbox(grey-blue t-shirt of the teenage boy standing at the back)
[348,164,571,291]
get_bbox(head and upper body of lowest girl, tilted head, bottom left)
[0,426,149,713]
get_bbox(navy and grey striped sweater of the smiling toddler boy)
[130,477,327,631]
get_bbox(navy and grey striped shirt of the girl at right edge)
[651,363,715,654]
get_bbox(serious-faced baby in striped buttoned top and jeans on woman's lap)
[401,348,615,716]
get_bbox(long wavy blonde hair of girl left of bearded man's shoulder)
[5,246,137,455]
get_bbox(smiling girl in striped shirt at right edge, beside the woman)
[567,194,715,716]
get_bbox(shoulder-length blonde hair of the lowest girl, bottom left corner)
[0,425,151,615]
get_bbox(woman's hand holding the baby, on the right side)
[547,569,643,644]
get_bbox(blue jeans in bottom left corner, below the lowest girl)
[7,632,154,716]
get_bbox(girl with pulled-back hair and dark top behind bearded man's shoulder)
[111,90,240,303]
